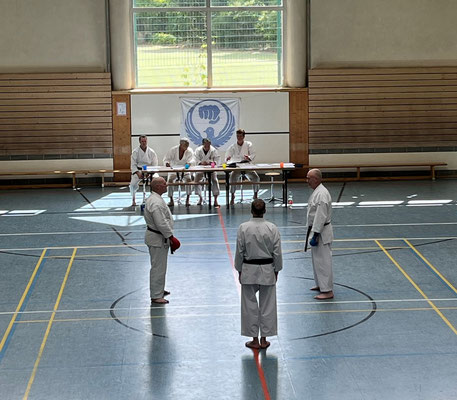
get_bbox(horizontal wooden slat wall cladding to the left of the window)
[0,73,112,156]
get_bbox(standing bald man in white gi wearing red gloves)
[144,177,179,304]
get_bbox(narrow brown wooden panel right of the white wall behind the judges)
[289,89,309,178]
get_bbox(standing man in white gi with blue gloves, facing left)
[305,169,333,300]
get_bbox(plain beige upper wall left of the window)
[0,0,106,72]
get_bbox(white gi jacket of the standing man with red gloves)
[144,192,173,247]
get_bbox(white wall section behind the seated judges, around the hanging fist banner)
[132,92,289,163]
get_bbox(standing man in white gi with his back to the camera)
[235,199,282,349]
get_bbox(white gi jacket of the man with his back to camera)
[235,218,282,286]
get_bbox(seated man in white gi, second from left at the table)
[163,138,195,207]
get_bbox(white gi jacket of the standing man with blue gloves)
[307,183,333,244]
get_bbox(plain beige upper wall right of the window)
[311,0,457,68]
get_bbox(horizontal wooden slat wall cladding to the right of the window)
[309,67,457,150]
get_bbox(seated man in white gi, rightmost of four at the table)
[225,129,260,205]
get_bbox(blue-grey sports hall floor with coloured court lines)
[0,180,457,400]
